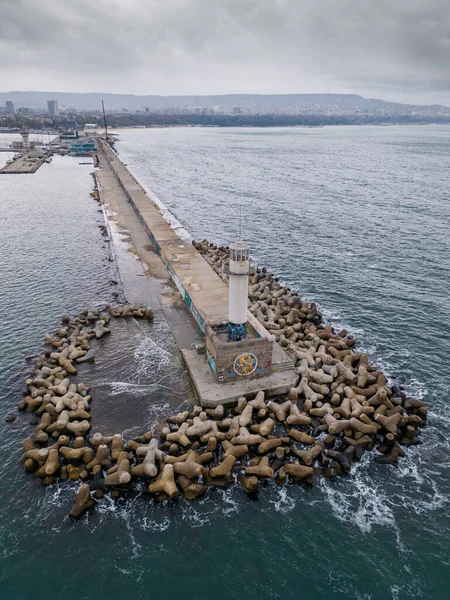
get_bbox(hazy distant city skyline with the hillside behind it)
[0,91,450,118]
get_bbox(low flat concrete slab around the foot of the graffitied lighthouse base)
[181,344,298,408]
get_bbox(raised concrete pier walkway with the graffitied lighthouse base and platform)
[99,140,296,408]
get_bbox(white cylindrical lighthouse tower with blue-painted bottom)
[227,241,255,342]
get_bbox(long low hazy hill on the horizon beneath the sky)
[0,91,450,114]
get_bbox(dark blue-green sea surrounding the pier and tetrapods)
[0,126,450,600]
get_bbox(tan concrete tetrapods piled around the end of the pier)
[15,260,427,518]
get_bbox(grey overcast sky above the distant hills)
[0,0,450,105]
